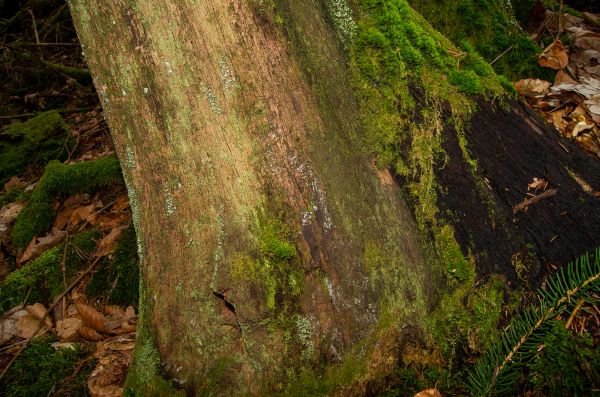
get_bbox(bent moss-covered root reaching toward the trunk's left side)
[12,156,123,247]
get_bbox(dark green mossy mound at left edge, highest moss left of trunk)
[0,110,71,185]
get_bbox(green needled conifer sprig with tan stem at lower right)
[468,247,600,396]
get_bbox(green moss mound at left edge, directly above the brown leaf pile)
[0,230,99,313]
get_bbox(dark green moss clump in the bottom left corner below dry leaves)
[0,337,94,397]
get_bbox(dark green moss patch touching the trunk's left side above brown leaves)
[86,226,139,306]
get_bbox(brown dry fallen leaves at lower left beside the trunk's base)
[0,303,137,397]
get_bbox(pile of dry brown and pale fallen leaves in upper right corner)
[515,12,600,157]
